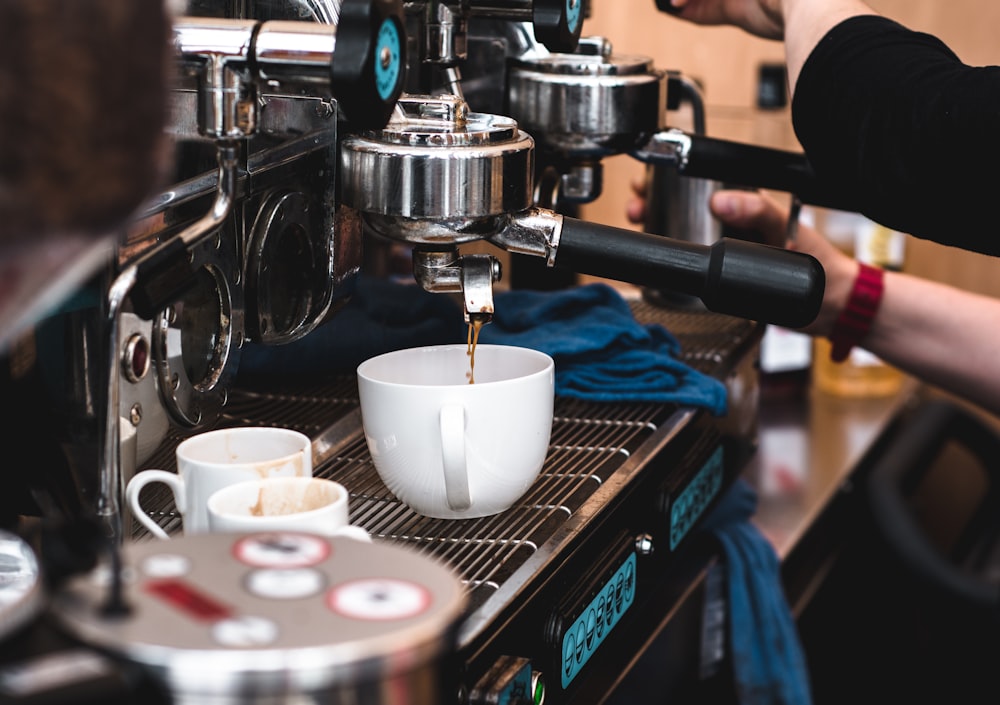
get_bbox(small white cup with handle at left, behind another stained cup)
[125,426,312,539]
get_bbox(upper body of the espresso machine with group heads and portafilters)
[0,0,823,541]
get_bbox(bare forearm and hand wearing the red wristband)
[711,191,1000,414]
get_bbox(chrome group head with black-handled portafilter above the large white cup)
[341,96,825,328]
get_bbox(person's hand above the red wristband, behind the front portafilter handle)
[709,190,858,336]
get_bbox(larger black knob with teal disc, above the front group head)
[330,0,406,129]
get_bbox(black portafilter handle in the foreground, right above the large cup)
[555,217,826,328]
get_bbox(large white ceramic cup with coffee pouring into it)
[358,345,555,519]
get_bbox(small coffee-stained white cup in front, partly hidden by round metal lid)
[208,477,371,541]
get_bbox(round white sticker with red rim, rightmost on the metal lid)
[327,578,431,621]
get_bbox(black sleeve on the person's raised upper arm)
[792,16,1000,255]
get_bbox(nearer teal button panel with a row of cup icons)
[559,553,636,688]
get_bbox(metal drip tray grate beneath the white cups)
[134,390,672,604]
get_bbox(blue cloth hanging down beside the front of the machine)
[703,479,812,705]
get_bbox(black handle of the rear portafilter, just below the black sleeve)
[679,135,859,211]
